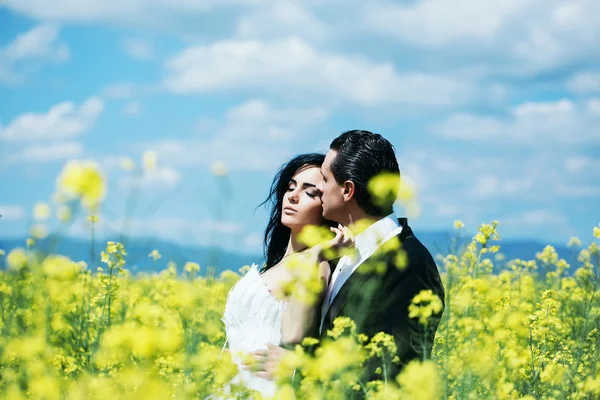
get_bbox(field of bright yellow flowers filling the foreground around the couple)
[0,159,600,400]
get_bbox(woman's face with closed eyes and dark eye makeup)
[281,166,323,229]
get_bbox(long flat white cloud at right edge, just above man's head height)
[431,100,600,146]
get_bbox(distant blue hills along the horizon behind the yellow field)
[0,231,576,274]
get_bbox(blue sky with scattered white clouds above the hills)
[0,0,600,252]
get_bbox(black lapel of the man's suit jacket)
[323,218,414,331]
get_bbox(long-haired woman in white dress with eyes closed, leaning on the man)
[223,153,352,397]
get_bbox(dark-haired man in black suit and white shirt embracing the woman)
[241,130,444,388]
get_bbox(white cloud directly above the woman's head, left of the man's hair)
[145,99,329,170]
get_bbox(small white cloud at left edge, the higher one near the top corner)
[0,24,70,83]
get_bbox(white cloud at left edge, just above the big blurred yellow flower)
[0,97,104,142]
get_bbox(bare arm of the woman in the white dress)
[281,260,331,345]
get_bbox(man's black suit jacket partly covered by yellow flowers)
[316,218,444,383]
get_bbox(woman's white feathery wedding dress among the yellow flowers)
[223,264,287,397]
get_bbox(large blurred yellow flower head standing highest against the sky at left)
[56,160,106,209]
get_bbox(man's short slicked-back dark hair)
[329,130,400,216]
